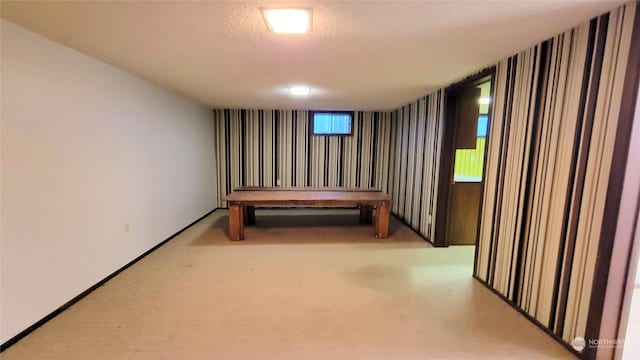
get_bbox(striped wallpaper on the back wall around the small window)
[213,109,393,207]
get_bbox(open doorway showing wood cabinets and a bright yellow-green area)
[435,71,493,246]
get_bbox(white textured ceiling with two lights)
[1,1,622,110]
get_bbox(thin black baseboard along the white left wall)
[0,208,220,353]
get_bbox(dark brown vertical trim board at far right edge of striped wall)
[583,4,640,359]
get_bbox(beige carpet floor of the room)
[0,210,572,360]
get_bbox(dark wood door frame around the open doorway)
[433,66,496,248]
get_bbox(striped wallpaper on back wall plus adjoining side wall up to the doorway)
[213,91,444,243]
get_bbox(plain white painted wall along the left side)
[0,20,217,342]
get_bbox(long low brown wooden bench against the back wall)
[225,187,391,240]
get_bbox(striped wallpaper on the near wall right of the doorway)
[474,3,638,352]
